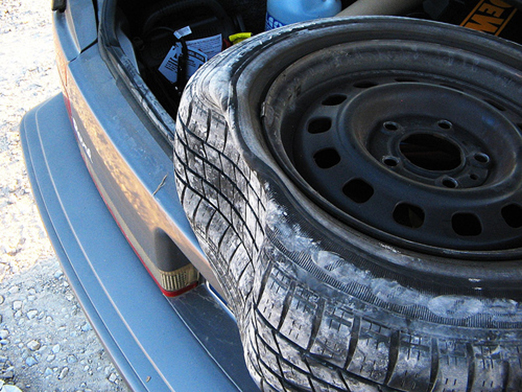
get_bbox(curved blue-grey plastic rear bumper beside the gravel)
[21,95,256,391]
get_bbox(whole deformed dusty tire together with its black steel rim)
[174,17,522,392]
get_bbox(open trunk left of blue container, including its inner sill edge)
[102,0,266,142]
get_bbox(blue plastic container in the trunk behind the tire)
[265,0,342,30]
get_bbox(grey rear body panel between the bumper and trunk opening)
[54,5,223,292]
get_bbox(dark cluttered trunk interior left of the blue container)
[116,0,266,119]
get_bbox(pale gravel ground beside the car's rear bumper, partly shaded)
[0,0,127,392]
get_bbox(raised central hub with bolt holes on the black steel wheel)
[343,82,500,189]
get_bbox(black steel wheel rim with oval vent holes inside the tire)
[264,31,522,259]
